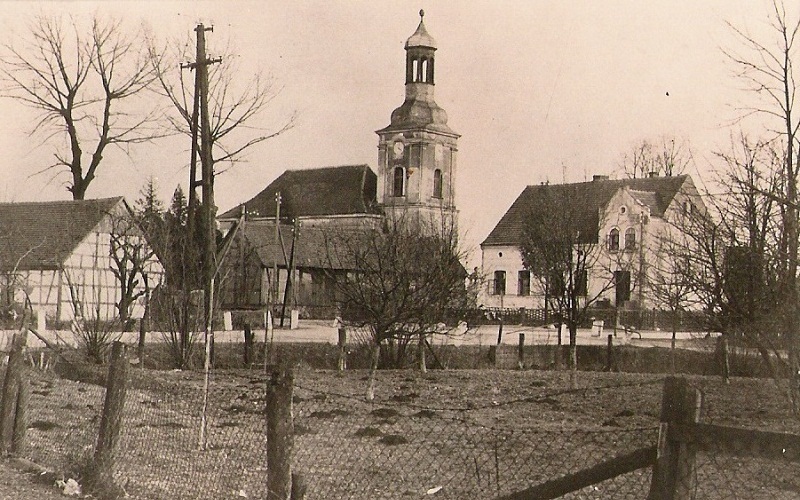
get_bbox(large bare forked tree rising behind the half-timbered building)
[0,17,163,200]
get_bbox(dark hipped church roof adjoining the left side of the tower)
[219,165,378,219]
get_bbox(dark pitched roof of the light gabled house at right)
[481,175,693,246]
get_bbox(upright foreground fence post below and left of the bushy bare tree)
[266,368,294,500]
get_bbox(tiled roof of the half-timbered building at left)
[0,196,123,271]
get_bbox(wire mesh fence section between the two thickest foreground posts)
[295,380,657,499]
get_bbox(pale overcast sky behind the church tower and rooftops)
[0,0,792,258]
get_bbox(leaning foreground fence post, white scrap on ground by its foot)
[87,342,128,497]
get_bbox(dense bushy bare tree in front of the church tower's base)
[326,217,469,400]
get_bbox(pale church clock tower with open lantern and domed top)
[376,10,459,229]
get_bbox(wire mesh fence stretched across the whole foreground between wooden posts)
[4,338,800,500]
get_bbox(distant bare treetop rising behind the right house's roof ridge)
[620,136,693,179]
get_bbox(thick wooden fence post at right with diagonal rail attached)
[647,377,703,500]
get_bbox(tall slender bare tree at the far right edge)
[725,0,800,415]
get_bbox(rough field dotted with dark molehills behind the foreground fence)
[6,367,800,500]
